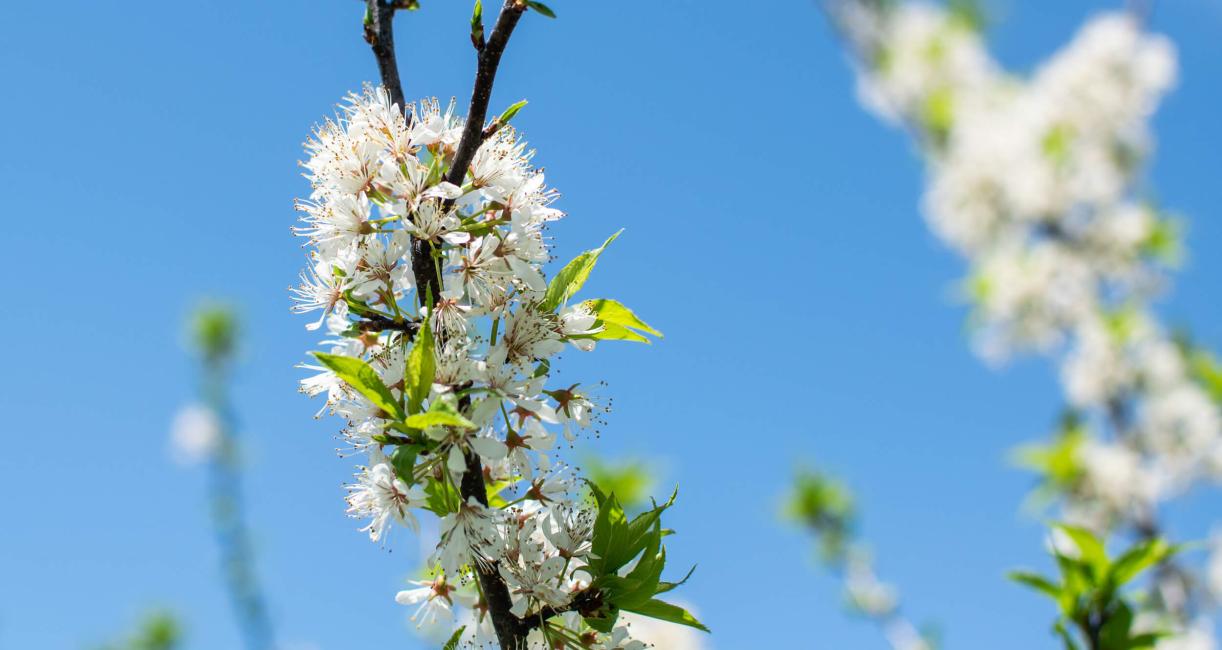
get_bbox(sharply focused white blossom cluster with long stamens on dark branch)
[292,88,674,650]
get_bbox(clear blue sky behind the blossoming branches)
[0,0,1222,650]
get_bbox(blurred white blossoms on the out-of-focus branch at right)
[836,0,1222,635]
